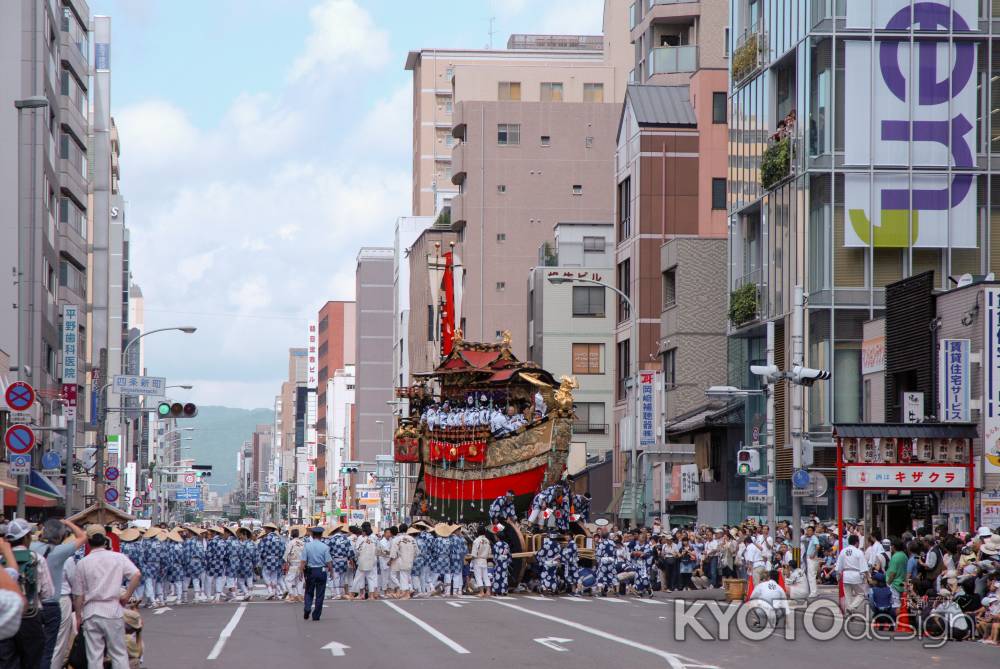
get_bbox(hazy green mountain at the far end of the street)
[178,406,274,495]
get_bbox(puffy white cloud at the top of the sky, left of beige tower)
[289,0,389,81]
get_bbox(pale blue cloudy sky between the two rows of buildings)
[90,0,603,409]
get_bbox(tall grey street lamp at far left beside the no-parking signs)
[14,95,49,518]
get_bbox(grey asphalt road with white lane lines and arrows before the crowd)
[143,595,1000,669]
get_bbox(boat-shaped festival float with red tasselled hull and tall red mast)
[394,244,582,582]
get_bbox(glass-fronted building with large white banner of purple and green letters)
[728,0,1000,486]
